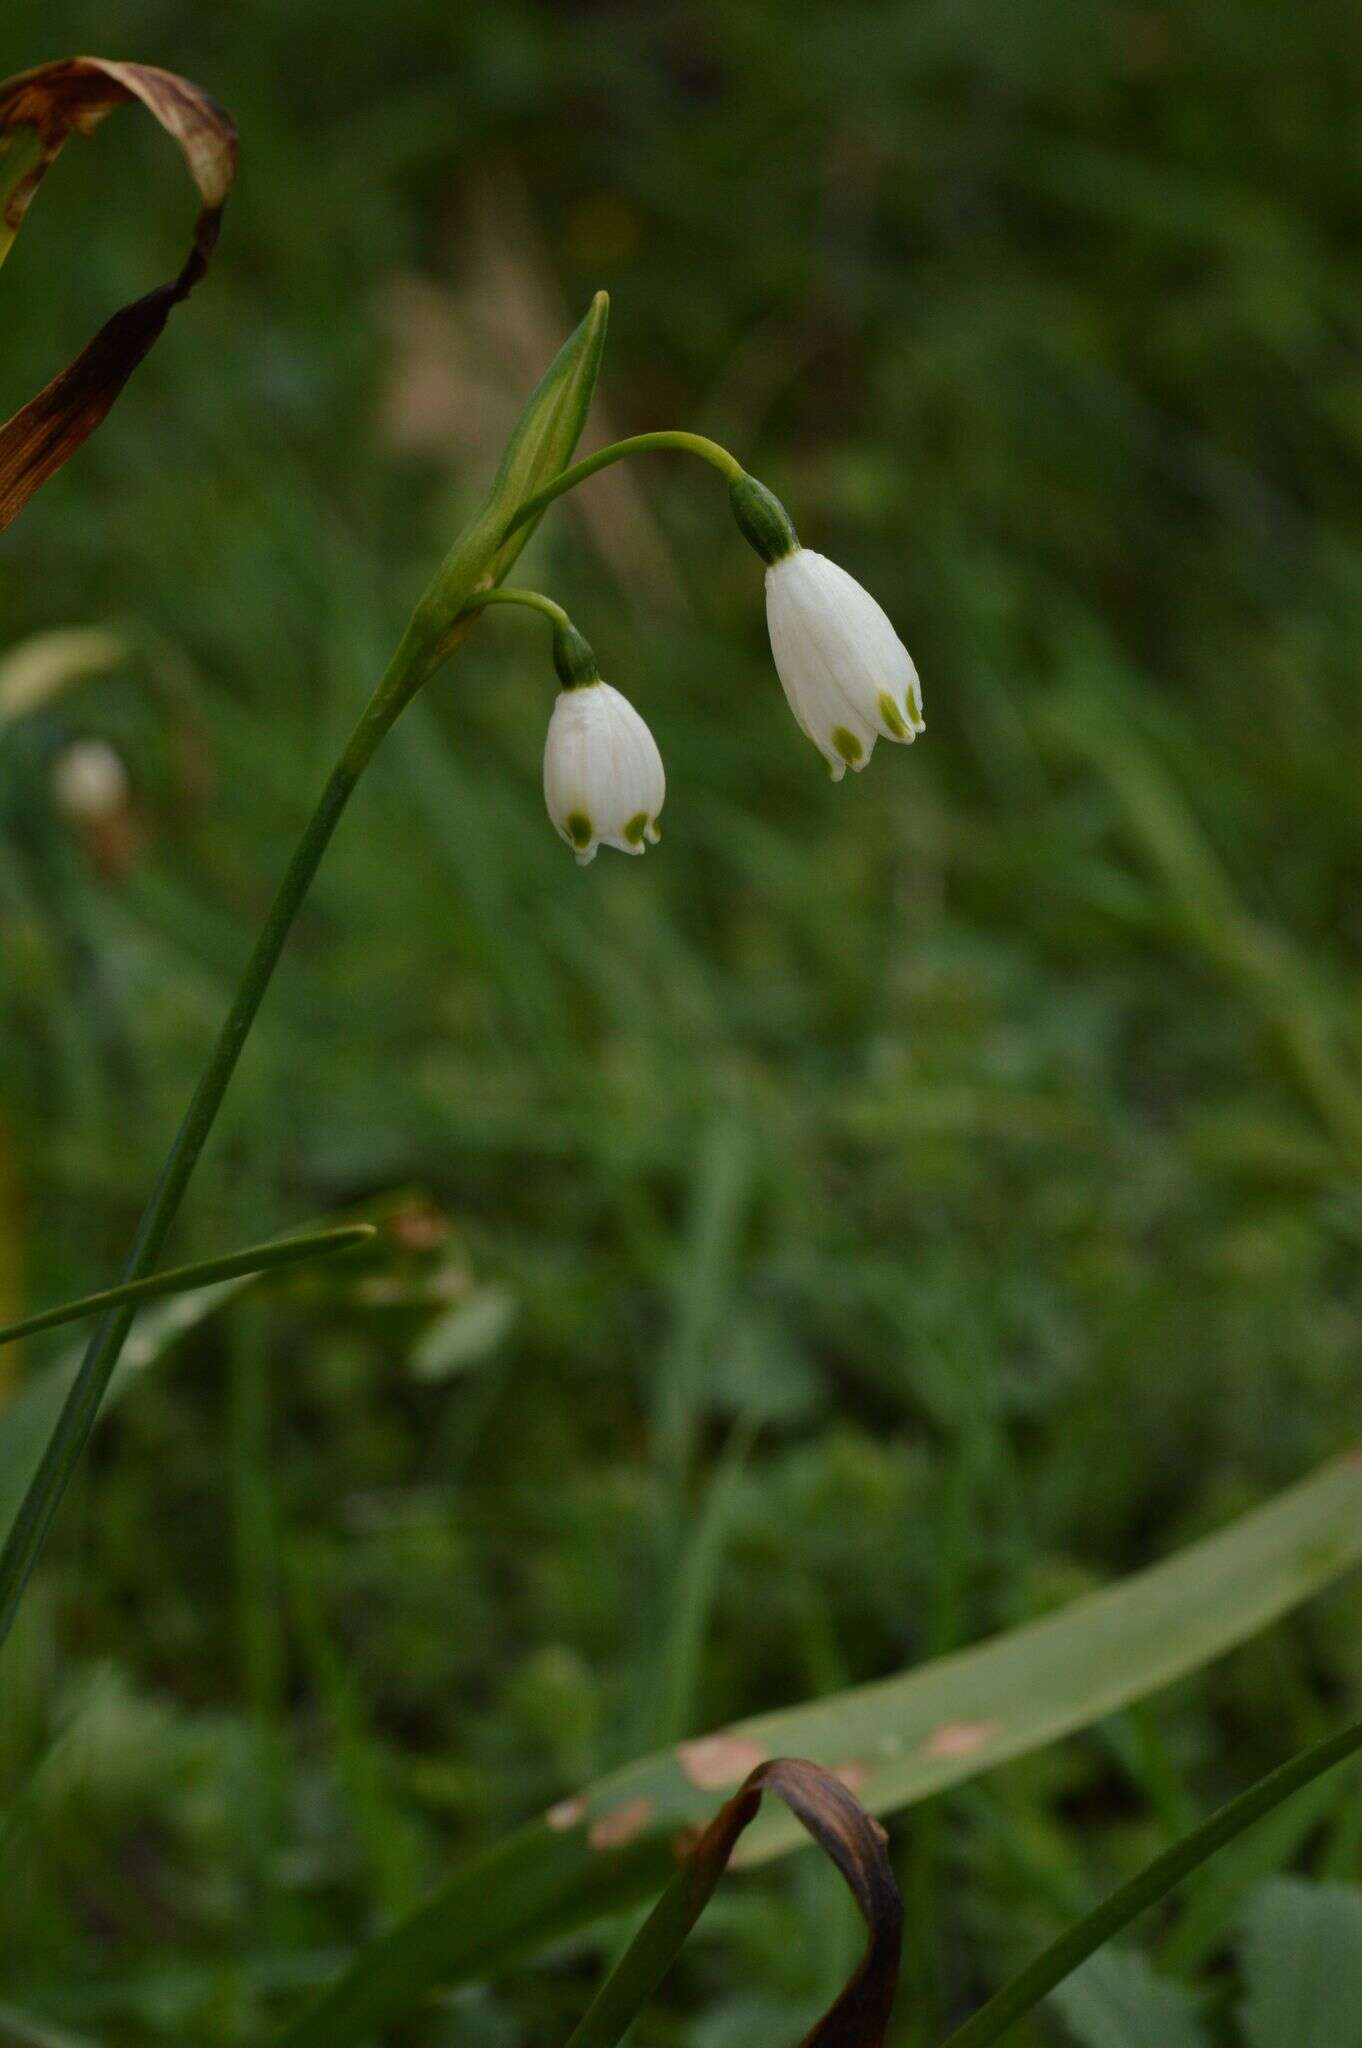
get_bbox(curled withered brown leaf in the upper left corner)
[0,57,238,528]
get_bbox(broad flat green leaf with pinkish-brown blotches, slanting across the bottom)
[285,1452,1362,2048]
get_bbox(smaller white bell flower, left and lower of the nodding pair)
[545,682,668,866]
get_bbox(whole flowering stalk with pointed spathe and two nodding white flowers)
[0,280,922,1642]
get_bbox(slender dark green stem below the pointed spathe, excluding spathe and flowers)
[0,621,430,1645]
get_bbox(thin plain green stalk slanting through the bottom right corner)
[942,1720,1362,2048]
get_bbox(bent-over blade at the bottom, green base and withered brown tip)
[567,1757,903,2048]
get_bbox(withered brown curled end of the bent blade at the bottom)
[688,1757,903,2048]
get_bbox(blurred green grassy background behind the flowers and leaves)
[0,0,1362,2048]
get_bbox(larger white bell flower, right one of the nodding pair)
[766,547,926,782]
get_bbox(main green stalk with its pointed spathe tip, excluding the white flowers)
[0,293,608,1645]
